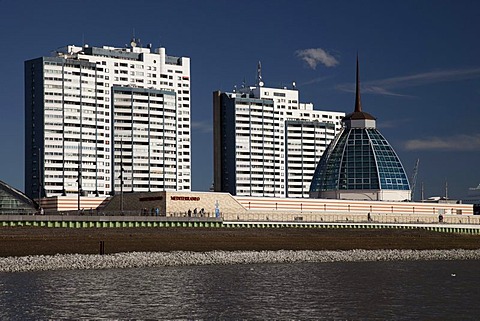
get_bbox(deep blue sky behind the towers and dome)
[0,0,480,198]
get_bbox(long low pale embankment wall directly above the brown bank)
[0,211,480,234]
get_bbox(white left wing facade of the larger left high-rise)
[43,61,109,195]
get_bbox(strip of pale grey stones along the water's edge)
[0,249,480,272]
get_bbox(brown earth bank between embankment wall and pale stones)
[0,227,480,257]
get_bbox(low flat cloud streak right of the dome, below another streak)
[405,134,480,152]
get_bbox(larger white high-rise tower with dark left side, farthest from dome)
[25,40,191,197]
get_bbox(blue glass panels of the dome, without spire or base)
[310,127,410,193]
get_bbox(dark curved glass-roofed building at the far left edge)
[0,181,38,215]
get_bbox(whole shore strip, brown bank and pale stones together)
[0,227,480,272]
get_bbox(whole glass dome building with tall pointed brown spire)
[310,58,411,201]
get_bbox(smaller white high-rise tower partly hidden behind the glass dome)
[213,66,345,197]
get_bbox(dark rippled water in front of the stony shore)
[0,261,480,320]
